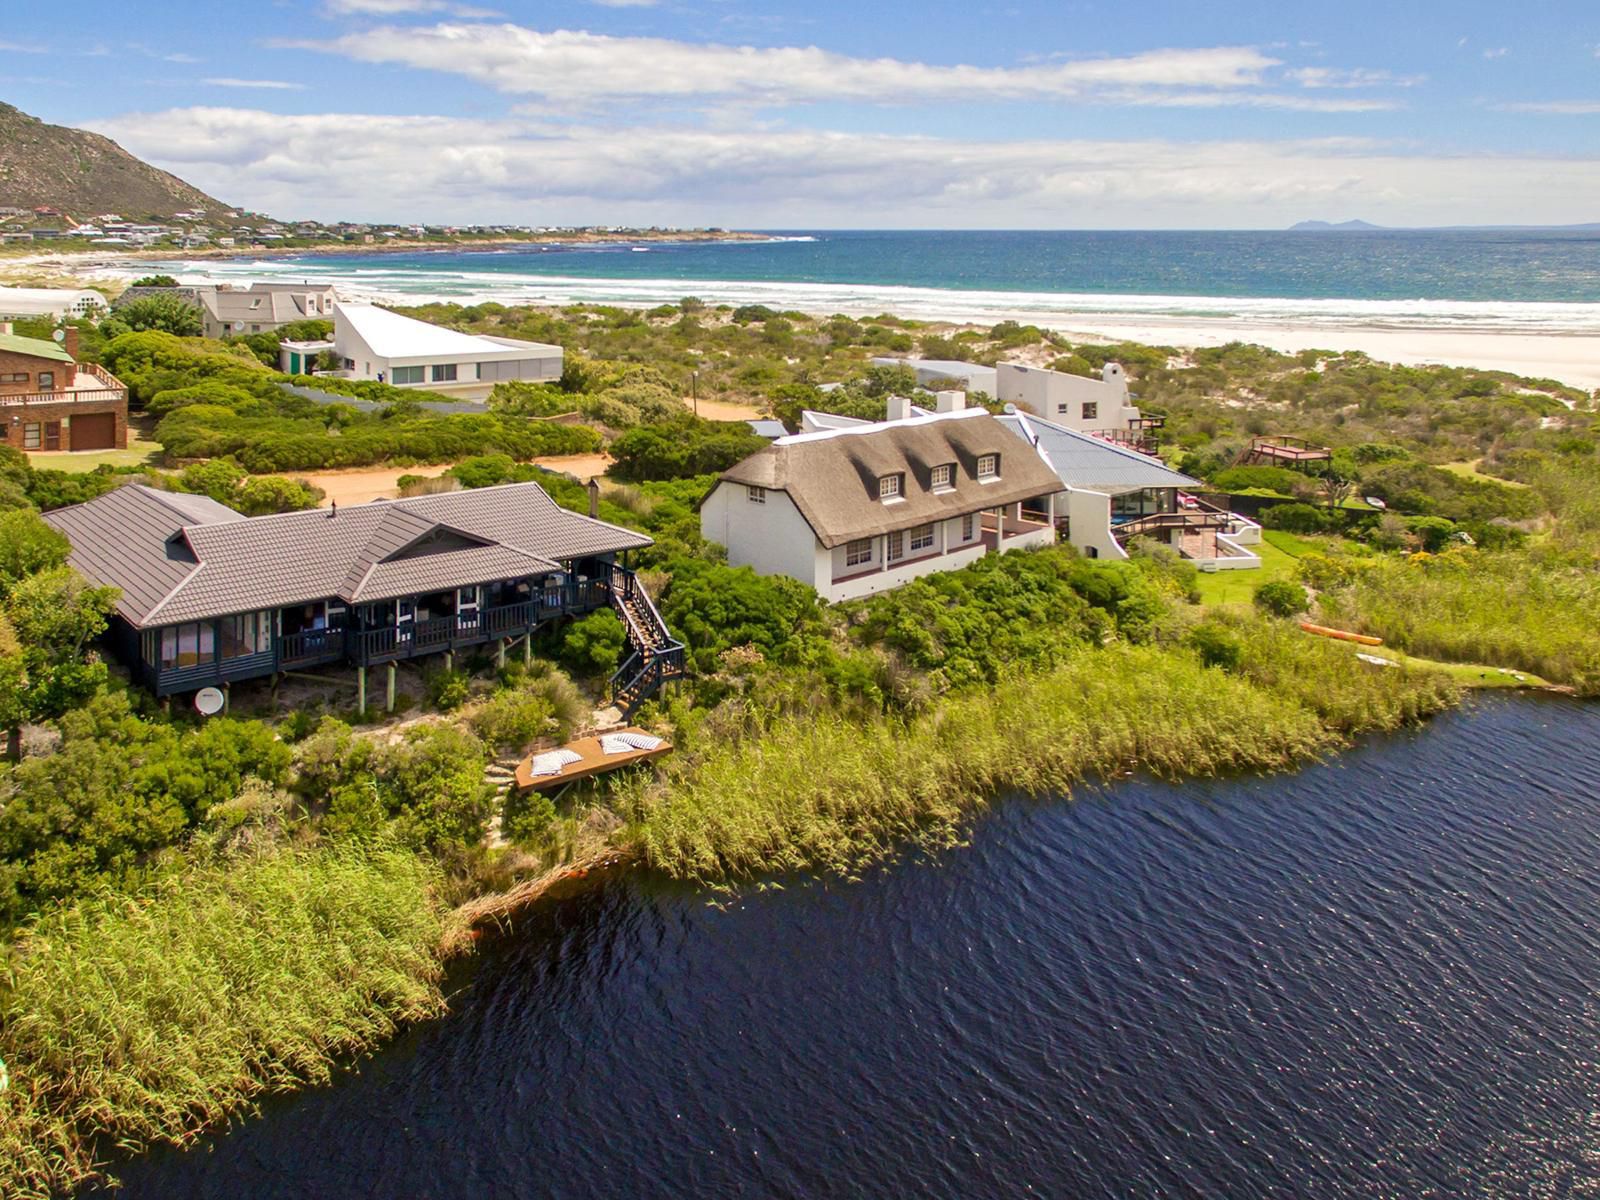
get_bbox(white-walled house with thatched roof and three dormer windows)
[701,392,1061,602]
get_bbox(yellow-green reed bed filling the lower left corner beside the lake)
[0,848,443,1200]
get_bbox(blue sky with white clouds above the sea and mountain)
[0,0,1600,229]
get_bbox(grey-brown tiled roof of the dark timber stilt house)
[46,483,650,626]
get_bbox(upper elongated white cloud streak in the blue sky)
[280,22,1401,112]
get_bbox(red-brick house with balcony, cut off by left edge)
[0,322,128,450]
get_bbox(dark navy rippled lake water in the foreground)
[106,699,1600,1200]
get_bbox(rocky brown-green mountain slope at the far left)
[0,104,230,219]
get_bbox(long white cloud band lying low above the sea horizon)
[94,107,1600,229]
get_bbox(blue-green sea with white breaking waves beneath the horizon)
[142,230,1600,333]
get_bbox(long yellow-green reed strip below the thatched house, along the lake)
[630,640,1458,882]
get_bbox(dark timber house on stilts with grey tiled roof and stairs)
[45,483,683,707]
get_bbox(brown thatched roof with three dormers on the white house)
[722,408,1061,547]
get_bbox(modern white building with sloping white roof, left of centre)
[278,302,562,400]
